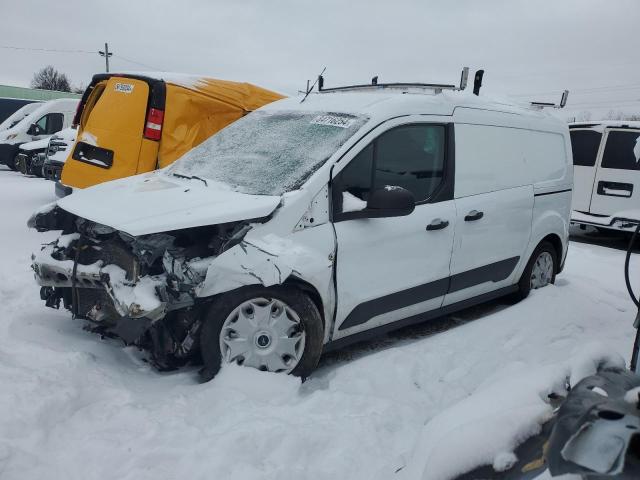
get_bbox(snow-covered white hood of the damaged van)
[57,172,280,236]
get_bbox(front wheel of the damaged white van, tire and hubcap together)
[200,286,323,381]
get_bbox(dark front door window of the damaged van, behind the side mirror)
[334,124,445,212]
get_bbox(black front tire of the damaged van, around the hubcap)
[200,285,324,382]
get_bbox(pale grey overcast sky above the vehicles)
[0,0,640,117]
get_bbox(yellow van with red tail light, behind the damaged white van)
[56,73,283,196]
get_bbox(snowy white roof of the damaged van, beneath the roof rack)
[263,87,552,125]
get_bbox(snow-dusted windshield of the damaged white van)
[168,111,367,195]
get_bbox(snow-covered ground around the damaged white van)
[0,167,640,480]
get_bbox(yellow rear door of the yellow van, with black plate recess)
[62,77,149,188]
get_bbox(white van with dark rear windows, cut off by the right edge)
[569,121,640,231]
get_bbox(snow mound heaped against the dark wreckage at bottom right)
[406,344,624,480]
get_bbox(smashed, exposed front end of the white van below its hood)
[28,204,258,369]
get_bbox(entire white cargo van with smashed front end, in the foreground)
[29,80,573,378]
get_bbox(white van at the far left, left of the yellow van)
[0,98,79,170]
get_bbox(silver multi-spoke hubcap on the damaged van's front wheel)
[220,298,305,373]
